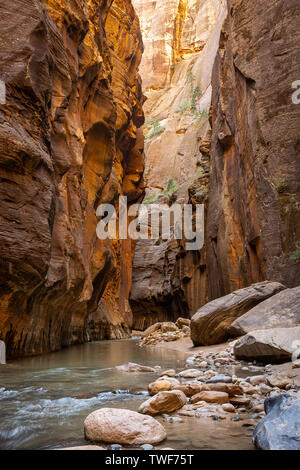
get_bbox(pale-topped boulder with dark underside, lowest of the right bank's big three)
[234,326,300,364]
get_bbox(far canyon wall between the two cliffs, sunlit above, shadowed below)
[131,0,227,329]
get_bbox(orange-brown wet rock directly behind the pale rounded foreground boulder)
[139,390,187,415]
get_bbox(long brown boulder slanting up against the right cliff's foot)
[191,281,285,346]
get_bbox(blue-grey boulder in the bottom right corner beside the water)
[253,394,300,450]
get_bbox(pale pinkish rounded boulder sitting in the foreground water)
[84,408,167,445]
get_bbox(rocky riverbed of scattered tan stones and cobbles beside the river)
[68,328,300,450]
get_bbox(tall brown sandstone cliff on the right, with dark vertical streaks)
[207,0,300,298]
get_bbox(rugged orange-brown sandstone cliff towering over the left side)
[0,0,144,357]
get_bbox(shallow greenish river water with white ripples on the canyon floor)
[0,340,253,449]
